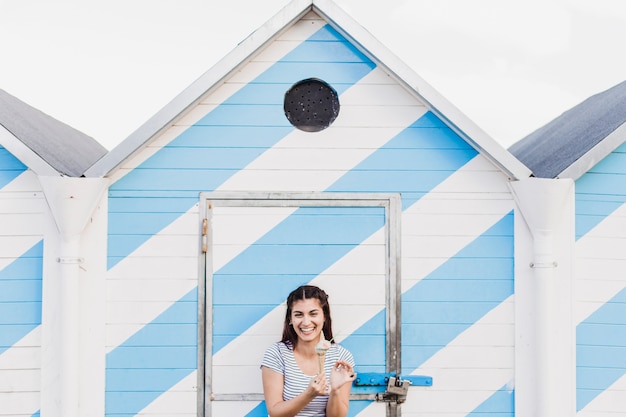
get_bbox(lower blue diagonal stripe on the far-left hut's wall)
[0,241,43,354]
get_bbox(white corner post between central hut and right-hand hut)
[510,178,576,417]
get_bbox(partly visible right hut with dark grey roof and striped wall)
[510,82,626,417]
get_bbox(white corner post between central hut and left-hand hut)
[39,176,108,417]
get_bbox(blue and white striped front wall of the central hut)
[105,9,515,417]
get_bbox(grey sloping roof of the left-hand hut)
[0,90,107,177]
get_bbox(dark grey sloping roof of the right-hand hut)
[509,81,626,179]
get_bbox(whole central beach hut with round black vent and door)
[80,0,544,417]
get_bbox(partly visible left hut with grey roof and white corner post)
[0,86,107,416]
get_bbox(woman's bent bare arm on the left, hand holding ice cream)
[261,366,326,417]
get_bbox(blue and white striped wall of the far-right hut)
[575,144,626,417]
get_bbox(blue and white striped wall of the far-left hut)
[0,146,44,417]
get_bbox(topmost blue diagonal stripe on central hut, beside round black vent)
[108,25,375,268]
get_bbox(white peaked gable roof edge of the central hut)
[85,0,530,179]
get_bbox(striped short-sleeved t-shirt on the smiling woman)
[261,342,354,417]
